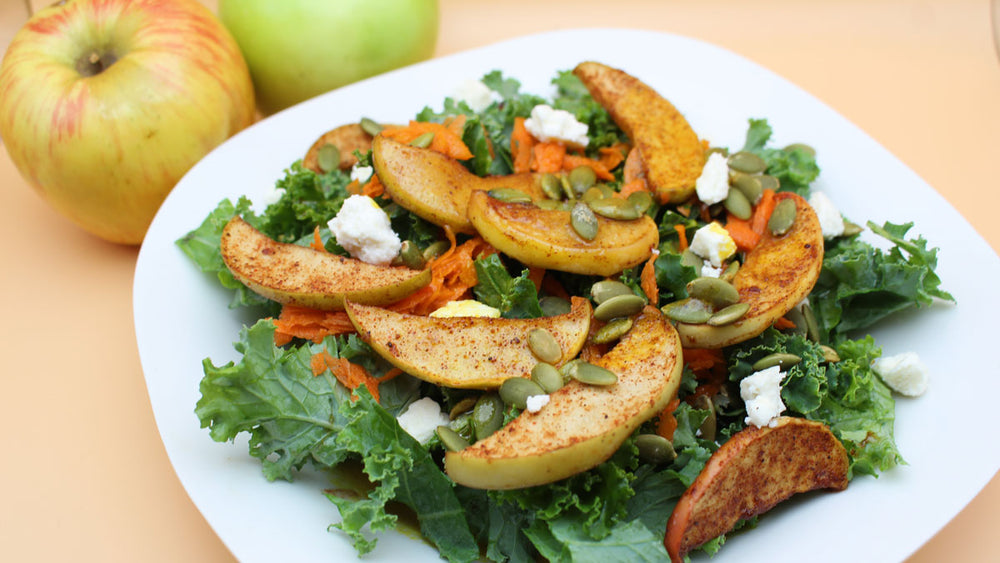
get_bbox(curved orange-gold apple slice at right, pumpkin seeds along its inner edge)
[677,192,823,348]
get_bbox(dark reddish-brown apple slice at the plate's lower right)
[664,417,848,563]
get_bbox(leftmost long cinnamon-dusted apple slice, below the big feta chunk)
[221,217,431,311]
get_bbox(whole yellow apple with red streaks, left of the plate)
[0,0,255,244]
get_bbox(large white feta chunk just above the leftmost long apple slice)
[327,195,402,266]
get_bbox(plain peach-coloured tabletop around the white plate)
[0,0,1000,563]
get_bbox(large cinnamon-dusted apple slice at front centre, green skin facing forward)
[445,306,684,489]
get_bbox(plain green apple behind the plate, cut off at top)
[219,0,438,114]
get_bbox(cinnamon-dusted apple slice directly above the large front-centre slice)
[346,297,593,389]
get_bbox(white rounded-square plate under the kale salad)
[134,30,1000,562]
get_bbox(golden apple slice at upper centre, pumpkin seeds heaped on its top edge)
[469,192,660,276]
